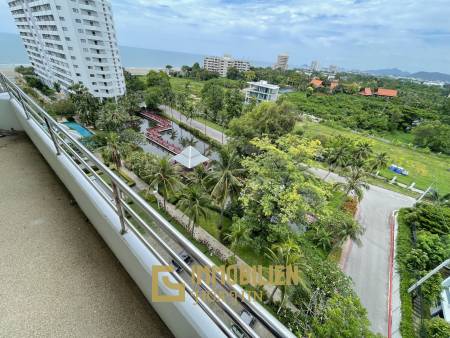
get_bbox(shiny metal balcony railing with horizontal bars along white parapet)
[0,73,294,337]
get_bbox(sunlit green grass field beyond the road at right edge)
[297,122,450,194]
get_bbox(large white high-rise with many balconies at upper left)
[8,0,125,98]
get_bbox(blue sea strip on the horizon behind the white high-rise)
[0,33,270,69]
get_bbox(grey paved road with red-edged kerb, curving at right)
[311,169,415,336]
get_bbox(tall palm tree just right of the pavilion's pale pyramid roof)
[208,150,244,230]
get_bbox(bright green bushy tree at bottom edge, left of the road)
[312,294,373,338]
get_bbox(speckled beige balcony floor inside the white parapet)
[0,135,172,337]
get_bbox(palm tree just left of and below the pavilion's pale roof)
[143,156,182,210]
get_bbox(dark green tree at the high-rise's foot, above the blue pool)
[69,83,100,125]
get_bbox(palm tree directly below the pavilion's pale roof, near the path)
[177,186,209,237]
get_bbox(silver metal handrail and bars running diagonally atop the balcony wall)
[0,73,294,337]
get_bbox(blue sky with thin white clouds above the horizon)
[0,0,450,73]
